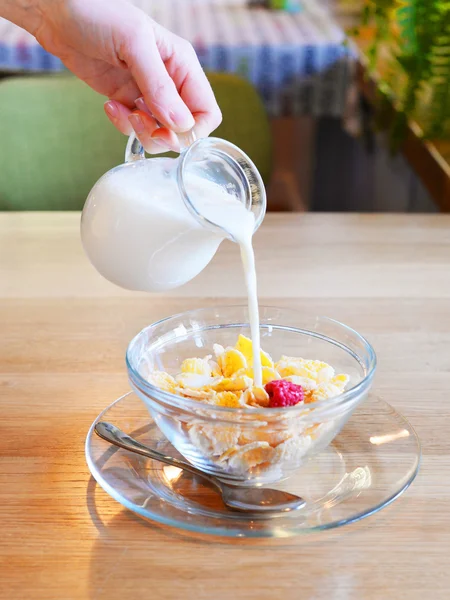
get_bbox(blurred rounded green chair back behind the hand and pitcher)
[0,74,271,210]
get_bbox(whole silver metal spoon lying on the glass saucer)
[95,421,306,517]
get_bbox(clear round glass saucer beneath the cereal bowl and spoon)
[86,392,420,538]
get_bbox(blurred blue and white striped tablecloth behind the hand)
[0,0,352,116]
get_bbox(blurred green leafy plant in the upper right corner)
[356,0,450,142]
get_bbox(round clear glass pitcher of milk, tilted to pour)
[81,133,266,292]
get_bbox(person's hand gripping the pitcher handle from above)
[32,0,222,154]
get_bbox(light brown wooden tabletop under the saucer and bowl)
[0,213,450,600]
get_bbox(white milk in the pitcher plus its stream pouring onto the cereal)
[81,159,262,386]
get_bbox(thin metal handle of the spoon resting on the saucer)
[94,421,220,488]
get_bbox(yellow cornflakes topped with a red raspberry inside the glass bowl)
[149,335,349,479]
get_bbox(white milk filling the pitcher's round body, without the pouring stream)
[81,159,223,292]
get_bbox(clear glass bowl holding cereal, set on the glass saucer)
[126,306,376,485]
